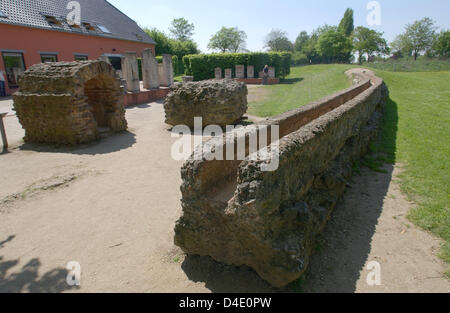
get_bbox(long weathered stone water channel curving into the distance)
[175,71,388,287]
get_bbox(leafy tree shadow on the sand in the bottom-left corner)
[0,236,77,293]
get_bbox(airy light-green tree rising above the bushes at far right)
[404,17,436,60]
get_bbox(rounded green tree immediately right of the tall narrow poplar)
[353,26,389,64]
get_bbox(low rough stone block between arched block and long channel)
[164,79,248,127]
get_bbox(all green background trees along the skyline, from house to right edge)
[145,8,450,74]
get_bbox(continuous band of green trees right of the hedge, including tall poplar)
[265,9,450,64]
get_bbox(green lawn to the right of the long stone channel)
[377,71,450,262]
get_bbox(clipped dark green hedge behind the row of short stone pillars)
[183,52,292,81]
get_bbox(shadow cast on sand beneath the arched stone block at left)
[19,131,136,155]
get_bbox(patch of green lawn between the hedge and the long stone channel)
[248,65,350,117]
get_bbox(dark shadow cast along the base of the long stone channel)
[182,99,398,293]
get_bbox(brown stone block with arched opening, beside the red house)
[14,61,127,145]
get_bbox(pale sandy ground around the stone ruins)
[0,101,450,292]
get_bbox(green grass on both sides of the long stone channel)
[249,65,450,275]
